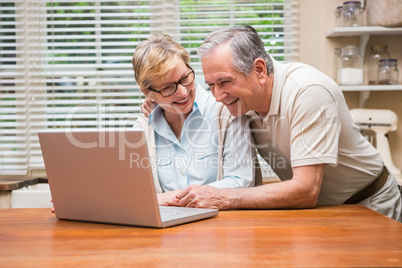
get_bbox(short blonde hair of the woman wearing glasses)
[131,34,190,93]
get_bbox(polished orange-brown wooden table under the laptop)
[0,205,402,268]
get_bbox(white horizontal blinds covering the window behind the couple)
[0,0,298,175]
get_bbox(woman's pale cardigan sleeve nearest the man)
[209,116,258,188]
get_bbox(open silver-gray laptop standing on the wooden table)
[38,130,218,228]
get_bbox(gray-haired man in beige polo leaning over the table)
[170,26,401,221]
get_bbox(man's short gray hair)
[197,25,274,75]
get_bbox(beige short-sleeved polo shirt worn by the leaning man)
[248,60,383,204]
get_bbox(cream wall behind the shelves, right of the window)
[299,0,402,169]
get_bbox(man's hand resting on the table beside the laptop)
[176,184,233,210]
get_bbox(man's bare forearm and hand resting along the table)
[176,164,324,210]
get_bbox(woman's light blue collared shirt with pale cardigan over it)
[149,85,254,192]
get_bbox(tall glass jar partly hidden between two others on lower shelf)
[366,45,389,85]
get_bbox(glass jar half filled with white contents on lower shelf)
[338,46,363,86]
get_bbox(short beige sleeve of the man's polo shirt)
[289,85,340,167]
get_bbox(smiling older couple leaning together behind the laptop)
[132,26,402,221]
